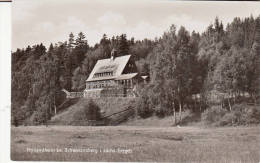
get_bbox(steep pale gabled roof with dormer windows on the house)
[87,55,131,82]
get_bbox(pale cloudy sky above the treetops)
[12,0,260,50]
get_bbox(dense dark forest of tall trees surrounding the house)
[11,16,260,125]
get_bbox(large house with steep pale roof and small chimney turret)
[84,50,140,98]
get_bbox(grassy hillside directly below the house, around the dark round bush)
[50,97,136,125]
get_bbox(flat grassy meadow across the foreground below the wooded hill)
[11,126,260,162]
